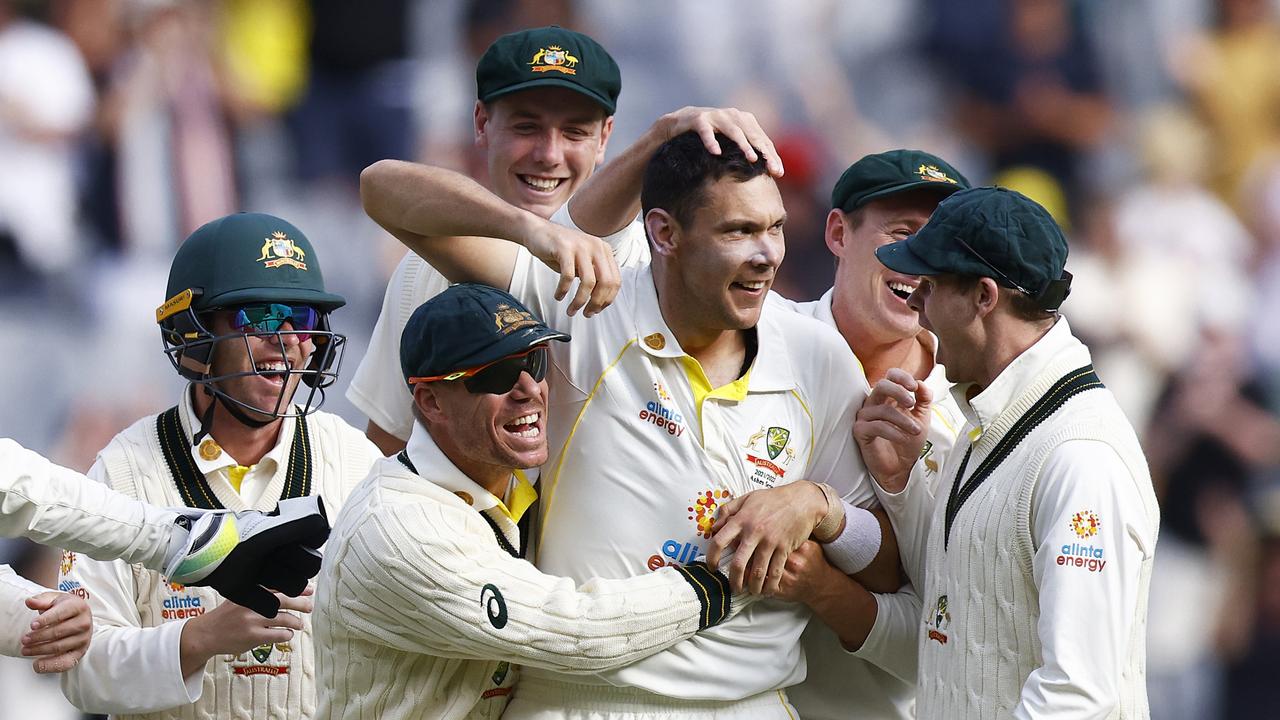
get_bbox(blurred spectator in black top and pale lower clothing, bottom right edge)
[1144,332,1280,720]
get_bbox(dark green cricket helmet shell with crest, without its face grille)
[157,213,347,318]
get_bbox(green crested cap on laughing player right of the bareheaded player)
[831,150,969,213]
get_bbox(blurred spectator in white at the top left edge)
[0,0,93,284]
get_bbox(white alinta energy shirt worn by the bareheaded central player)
[511,250,874,701]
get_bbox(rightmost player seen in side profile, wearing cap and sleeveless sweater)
[855,187,1160,719]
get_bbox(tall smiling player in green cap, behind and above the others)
[347,26,782,455]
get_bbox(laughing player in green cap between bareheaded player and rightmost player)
[556,147,969,720]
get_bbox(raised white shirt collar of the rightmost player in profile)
[951,316,1089,441]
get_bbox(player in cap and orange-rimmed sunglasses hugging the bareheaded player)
[316,283,742,720]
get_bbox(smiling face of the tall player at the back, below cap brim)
[475,87,613,218]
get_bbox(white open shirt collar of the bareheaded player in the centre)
[632,265,796,392]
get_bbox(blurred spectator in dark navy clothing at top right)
[940,0,1111,213]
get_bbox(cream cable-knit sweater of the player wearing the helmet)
[59,392,381,720]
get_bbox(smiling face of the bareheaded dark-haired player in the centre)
[646,176,786,342]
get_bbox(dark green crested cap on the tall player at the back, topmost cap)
[476,26,622,115]
